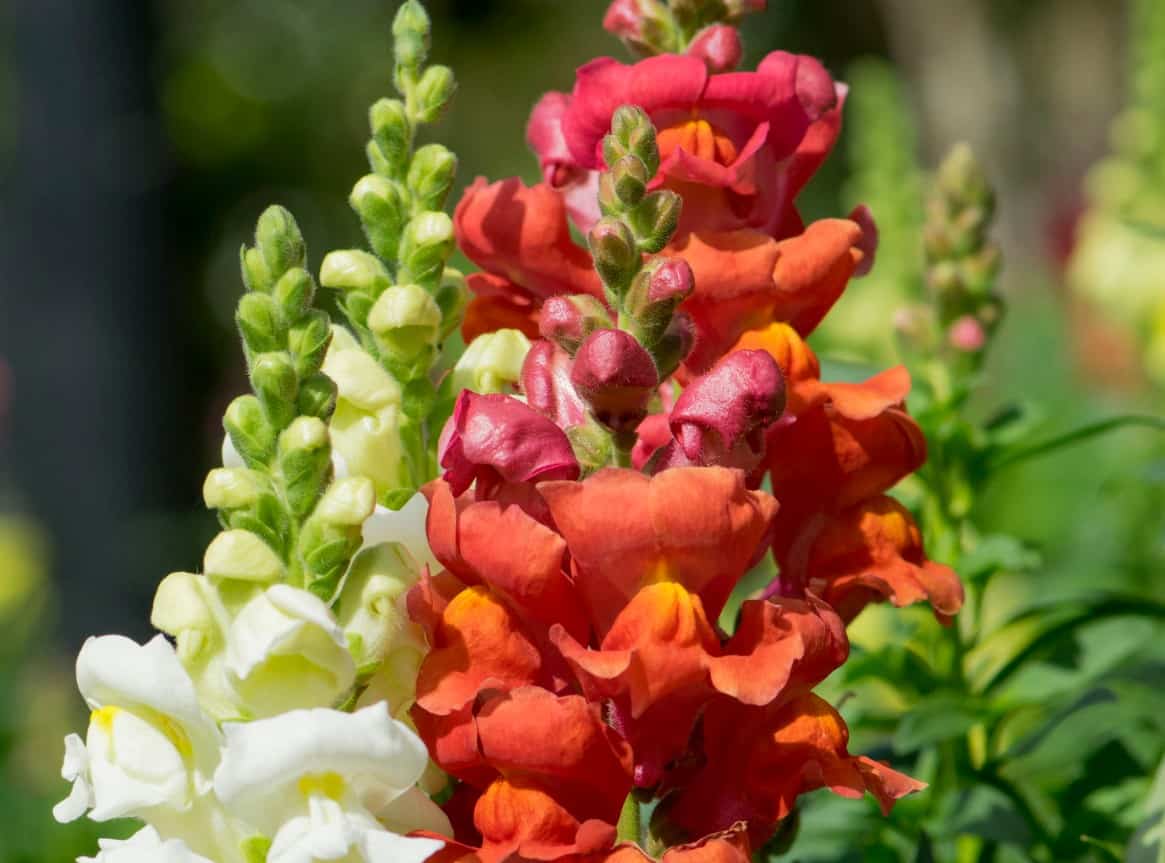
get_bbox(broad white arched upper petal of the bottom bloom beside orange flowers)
[214,703,428,833]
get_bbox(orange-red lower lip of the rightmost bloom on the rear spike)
[809,496,963,621]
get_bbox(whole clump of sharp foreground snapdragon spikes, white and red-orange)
[56,0,962,863]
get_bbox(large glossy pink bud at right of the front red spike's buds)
[665,351,785,471]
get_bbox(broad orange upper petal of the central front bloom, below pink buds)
[538,467,777,637]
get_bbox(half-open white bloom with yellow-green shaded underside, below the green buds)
[226,585,355,717]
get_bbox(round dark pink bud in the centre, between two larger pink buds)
[571,330,659,432]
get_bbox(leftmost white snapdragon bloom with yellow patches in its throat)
[52,636,219,821]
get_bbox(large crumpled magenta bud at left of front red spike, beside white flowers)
[438,390,579,498]
